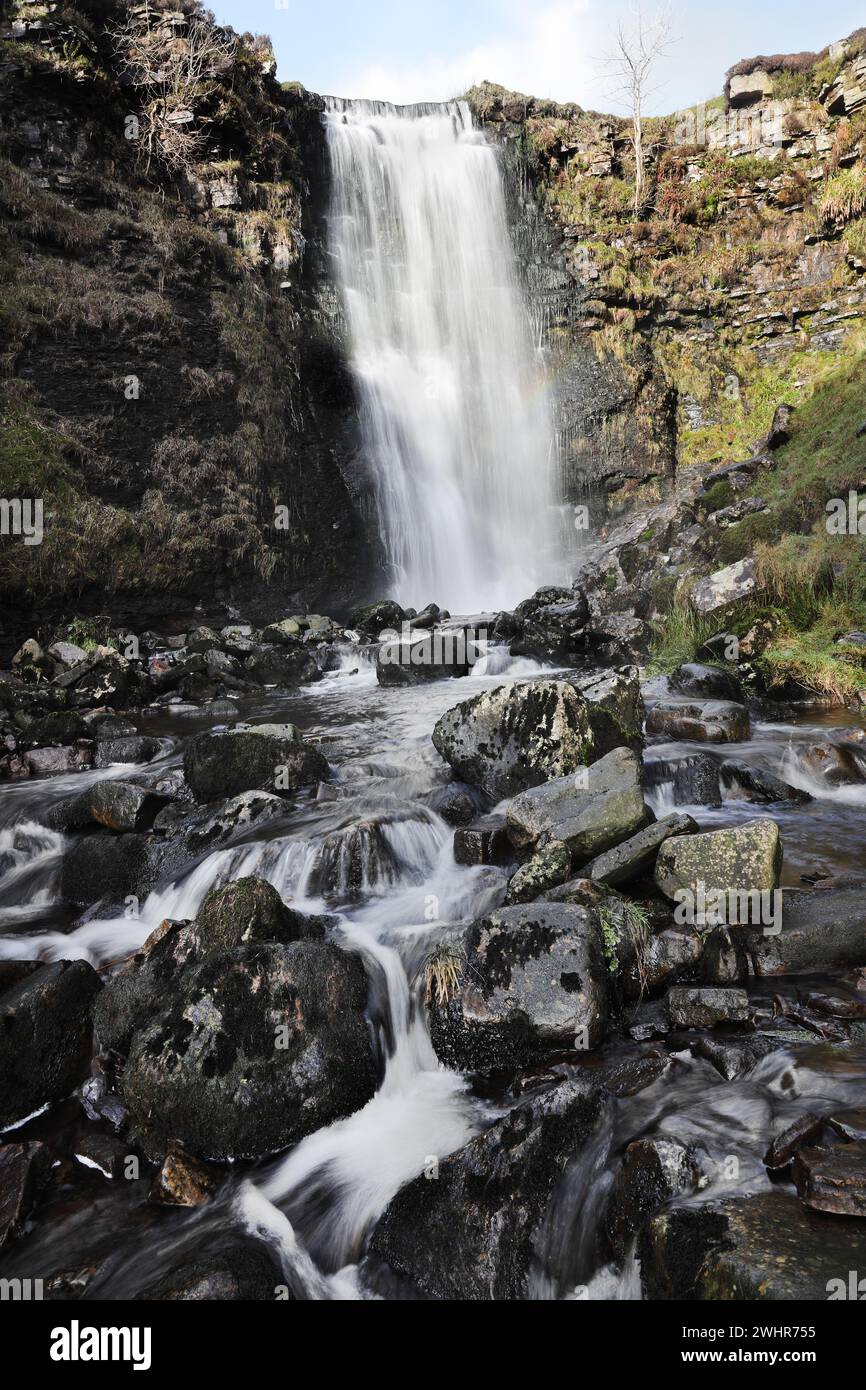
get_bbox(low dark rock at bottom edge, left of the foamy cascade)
[136,1240,285,1304]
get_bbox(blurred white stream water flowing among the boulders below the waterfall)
[0,648,866,1300]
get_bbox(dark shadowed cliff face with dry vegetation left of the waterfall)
[0,0,373,635]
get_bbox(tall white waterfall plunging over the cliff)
[325,99,564,613]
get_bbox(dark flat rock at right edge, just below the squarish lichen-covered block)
[744,888,866,976]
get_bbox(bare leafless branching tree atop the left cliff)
[108,0,238,172]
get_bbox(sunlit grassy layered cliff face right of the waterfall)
[468,31,866,512]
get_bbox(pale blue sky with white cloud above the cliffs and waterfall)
[210,0,866,114]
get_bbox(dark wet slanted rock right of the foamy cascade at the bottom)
[370,1079,607,1302]
